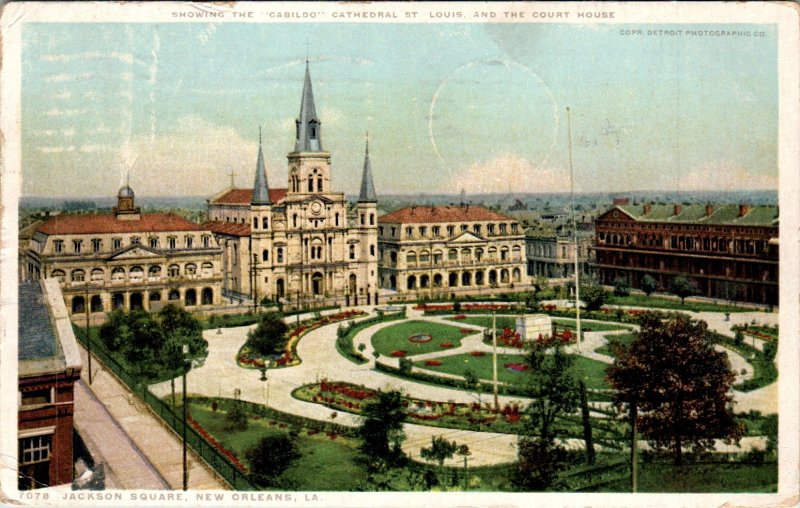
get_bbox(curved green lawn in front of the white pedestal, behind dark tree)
[414,353,608,389]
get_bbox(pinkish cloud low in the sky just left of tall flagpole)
[442,154,569,194]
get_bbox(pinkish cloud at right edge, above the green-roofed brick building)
[675,160,778,191]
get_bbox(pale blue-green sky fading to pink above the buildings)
[22,22,778,197]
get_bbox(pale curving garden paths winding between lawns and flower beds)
[150,308,777,466]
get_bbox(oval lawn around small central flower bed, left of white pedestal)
[372,320,478,356]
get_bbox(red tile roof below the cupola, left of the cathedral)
[38,213,202,235]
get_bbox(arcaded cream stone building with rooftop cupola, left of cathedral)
[20,185,222,322]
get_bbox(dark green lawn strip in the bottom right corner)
[598,462,778,493]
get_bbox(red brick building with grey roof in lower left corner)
[17,279,81,490]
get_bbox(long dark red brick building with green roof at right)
[595,202,778,305]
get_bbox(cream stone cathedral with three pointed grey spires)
[206,62,378,304]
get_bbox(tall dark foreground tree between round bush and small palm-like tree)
[359,390,406,464]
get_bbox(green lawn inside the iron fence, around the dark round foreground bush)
[190,403,367,491]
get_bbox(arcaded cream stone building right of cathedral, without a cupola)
[378,203,529,294]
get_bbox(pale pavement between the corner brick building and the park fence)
[75,347,228,490]
